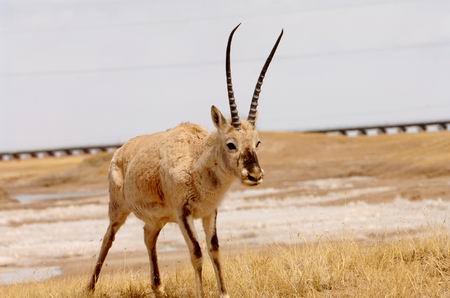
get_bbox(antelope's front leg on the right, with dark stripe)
[202,210,228,298]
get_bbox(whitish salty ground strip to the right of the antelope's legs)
[219,199,450,244]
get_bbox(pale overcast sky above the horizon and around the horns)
[0,0,450,151]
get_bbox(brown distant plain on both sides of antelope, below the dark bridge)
[0,132,450,197]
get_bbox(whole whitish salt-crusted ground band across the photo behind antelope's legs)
[0,179,450,278]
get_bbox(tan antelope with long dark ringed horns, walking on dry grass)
[88,24,283,297]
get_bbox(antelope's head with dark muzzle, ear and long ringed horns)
[211,24,283,186]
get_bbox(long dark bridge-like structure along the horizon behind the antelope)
[0,120,450,161]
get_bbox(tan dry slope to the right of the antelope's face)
[261,132,450,183]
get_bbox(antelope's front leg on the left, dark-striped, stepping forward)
[178,205,204,297]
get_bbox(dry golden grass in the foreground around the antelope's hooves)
[0,232,450,297]
